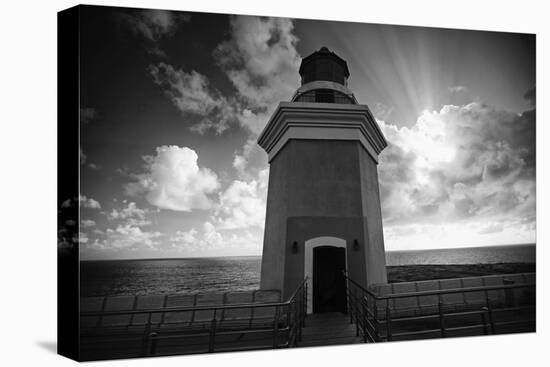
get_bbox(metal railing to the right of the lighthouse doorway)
[344,273,535,343]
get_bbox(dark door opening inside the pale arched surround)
[313,246,347,313]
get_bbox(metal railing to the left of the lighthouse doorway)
[80,278,307,356]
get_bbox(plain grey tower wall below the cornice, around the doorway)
[260,140,386,298]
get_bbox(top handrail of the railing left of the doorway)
[80,277,308,316]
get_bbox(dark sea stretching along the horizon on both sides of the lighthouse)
[80,245,535,297]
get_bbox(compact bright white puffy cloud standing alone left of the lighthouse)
[124,146,220,211]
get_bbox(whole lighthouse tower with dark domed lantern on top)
[258,47,387,313]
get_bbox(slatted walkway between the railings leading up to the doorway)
[298,312,363,347]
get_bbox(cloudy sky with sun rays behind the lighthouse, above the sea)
[68,7,536,260]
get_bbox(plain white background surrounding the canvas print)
[0,0,550,367]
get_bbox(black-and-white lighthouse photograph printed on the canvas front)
[57,5,537,360]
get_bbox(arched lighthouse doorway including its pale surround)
[304,237,347,313]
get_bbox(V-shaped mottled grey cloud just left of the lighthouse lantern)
[149,16,300,136]
